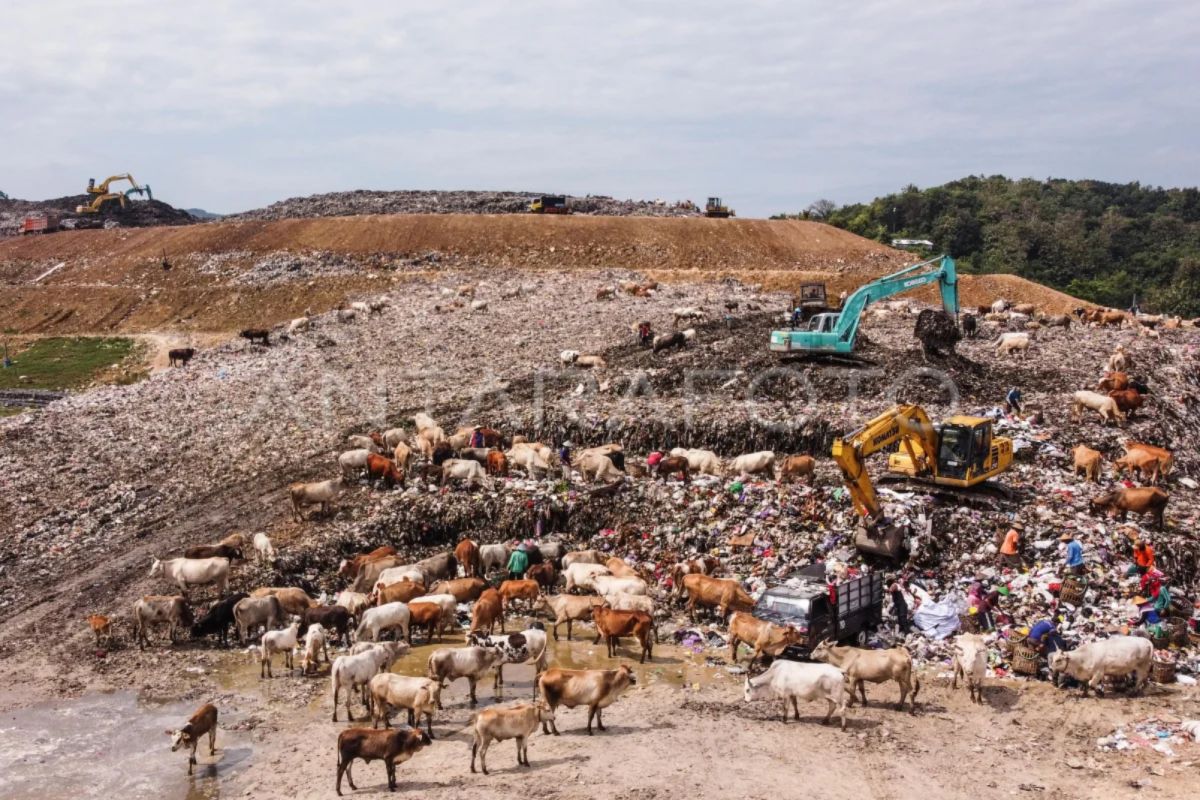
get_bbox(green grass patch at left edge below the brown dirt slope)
[0,336,136,390]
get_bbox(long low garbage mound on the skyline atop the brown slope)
[224,190,703,221]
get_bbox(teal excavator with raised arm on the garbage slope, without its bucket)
[770,255,959,359]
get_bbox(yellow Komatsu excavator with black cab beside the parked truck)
[833,403,1013,558]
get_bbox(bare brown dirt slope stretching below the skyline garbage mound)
[0,215,1078,333]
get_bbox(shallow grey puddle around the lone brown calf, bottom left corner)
[0,692,251,800]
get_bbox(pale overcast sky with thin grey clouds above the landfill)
[0,0,1200,216]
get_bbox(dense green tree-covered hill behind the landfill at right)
[773,175,1200,317]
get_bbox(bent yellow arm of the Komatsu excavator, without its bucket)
[833,403,937,522]
